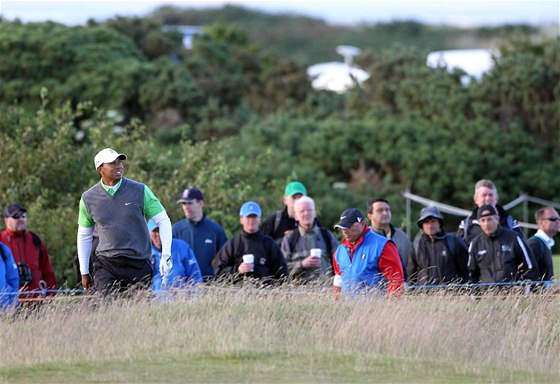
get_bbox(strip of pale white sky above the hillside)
[0,0,560,26]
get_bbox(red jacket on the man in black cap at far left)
[0,228,57,298]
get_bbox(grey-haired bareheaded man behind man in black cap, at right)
[457,179,525,245]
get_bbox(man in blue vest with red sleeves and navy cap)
[333,208,404,299]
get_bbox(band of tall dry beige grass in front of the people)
[0,287,560,372]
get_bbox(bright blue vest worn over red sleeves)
[335,231,389,294]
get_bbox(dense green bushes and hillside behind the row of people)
[0,6,560,285]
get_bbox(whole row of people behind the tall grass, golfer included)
[0,152,560,309]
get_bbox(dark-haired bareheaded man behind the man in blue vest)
[367,198,412,280]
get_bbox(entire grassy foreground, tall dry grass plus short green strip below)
[0,288,560,383]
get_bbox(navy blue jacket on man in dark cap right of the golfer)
[173,215,227,280]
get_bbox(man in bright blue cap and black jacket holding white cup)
[216,201,288,283]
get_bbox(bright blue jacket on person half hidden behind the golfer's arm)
[152,239,202,291]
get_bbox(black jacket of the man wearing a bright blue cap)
[215,230,289,279]
